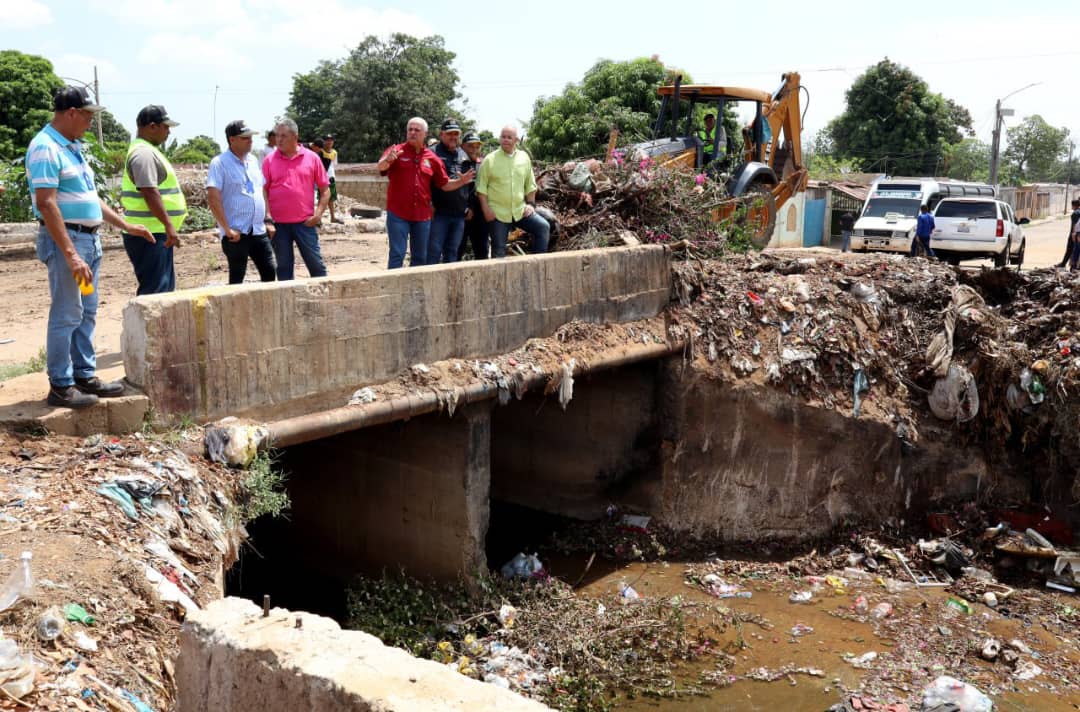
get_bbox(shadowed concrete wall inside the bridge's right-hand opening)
[491,362,658,519]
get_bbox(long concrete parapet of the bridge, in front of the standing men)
[121,246,671,419]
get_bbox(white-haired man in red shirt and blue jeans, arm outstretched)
[377,117,476,269]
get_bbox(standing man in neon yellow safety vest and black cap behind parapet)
[120,104,188,295]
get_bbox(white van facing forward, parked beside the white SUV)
[851,177,997,253]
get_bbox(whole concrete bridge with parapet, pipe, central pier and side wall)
[123,246,1002,581]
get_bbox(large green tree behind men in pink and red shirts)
[287,33,460,161]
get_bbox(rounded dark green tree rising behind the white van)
[827,57,971,175]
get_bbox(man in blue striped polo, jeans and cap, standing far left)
[26,86,153,408]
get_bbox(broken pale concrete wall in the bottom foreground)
[176,599,549,712]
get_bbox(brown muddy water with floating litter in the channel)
[553,562,1080,712]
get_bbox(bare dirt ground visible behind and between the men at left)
[0,225,387,365]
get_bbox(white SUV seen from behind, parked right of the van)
[930,198,1029,268]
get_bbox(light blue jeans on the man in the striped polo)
[38,227,102,388]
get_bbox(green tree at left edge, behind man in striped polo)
[0,50,64,160]
